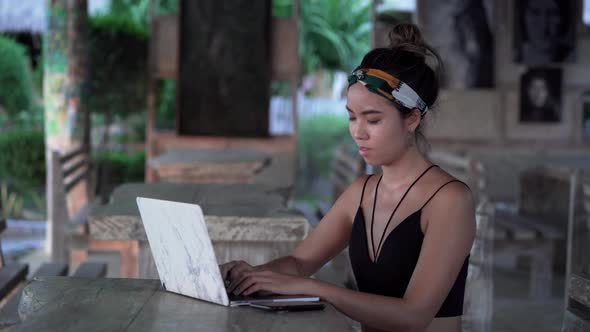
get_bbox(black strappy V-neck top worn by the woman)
[349,165,469,317]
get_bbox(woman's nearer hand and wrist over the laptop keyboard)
[233,271,313,295]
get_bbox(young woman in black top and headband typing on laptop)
[221,24,475,332]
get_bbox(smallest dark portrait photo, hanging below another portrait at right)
[520,68,562,123]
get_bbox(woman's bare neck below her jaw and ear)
[381,145,431,191]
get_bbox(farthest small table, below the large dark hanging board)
[149,148,271,183]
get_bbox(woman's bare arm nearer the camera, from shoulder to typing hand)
[237,184,475,331]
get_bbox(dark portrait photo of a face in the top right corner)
[514,0,577,65]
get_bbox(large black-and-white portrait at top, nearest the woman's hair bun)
[424,0,494,89]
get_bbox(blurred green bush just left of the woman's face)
[297,114,352,178]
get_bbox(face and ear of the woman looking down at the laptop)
[346,83,420,165]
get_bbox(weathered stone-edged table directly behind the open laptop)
[88,183,310,278]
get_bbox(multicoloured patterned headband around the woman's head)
[348,68,428,116]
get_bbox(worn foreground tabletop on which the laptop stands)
[11,277,353,332]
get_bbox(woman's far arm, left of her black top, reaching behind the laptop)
[221,176,366,291]
